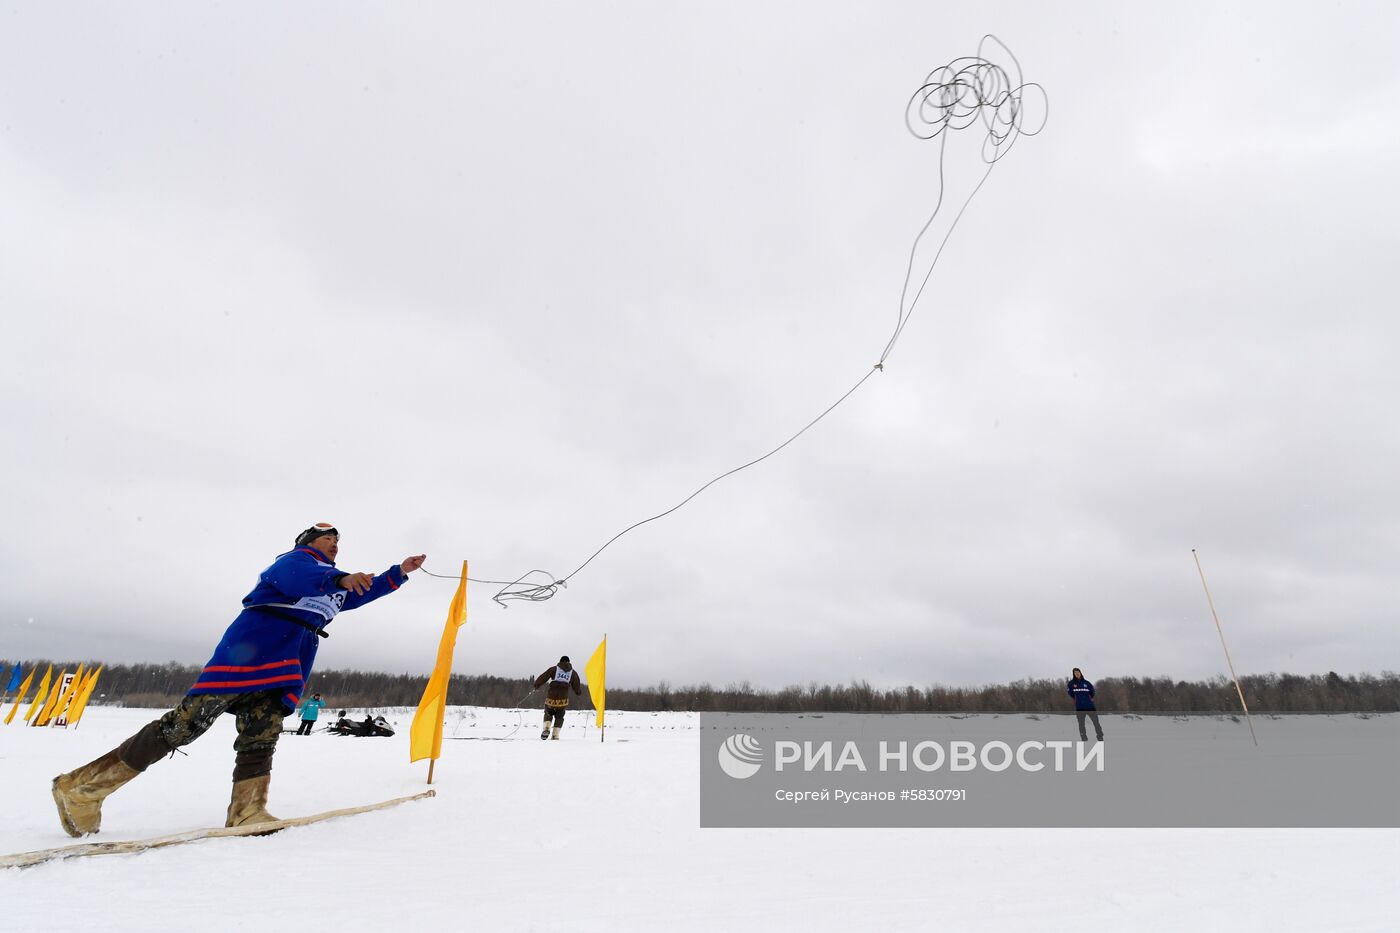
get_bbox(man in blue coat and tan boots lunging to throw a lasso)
[53,523,426,836]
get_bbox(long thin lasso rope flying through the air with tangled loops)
[423,35,1050,607]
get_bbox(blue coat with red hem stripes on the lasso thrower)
[189,548,407,714]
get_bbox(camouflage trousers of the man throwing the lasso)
[118,688,286,782]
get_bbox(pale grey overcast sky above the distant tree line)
[0,0,1400,686]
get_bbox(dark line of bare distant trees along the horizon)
[0,660,1400,713]
